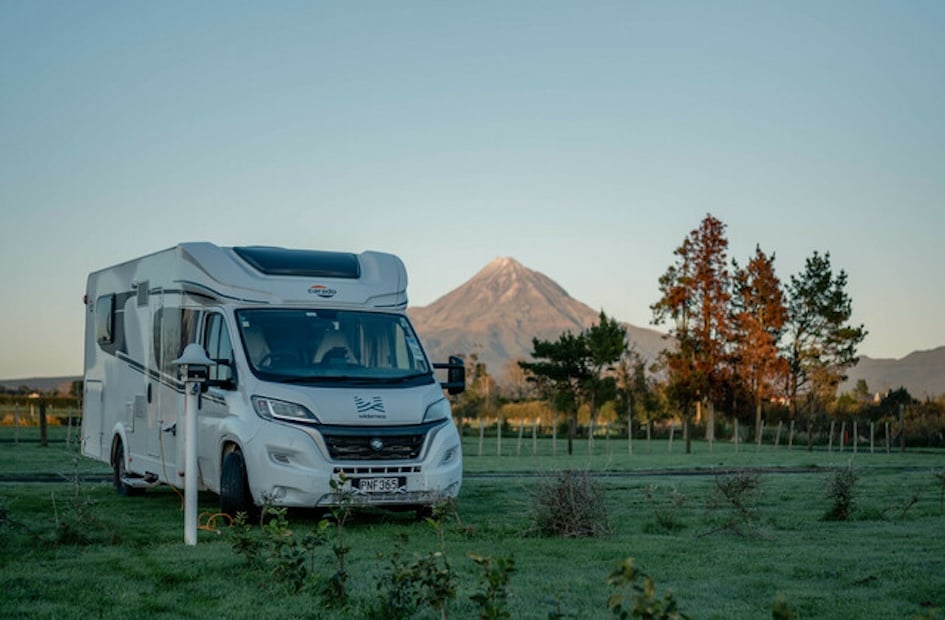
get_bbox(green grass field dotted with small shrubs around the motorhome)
[0,427,945,619]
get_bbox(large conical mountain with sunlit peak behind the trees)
[407,257,664,379]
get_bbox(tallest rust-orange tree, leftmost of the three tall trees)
[650,214,733,452]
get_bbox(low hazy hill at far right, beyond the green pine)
[840,346,945,398]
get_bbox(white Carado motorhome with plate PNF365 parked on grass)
[82,243,465,515]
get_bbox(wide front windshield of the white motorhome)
[236,308,435,385]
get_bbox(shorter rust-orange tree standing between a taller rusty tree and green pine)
[732,246,787,441]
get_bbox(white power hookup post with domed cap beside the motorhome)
[172,343,213,546]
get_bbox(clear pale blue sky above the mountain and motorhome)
[0,0,945,378]
